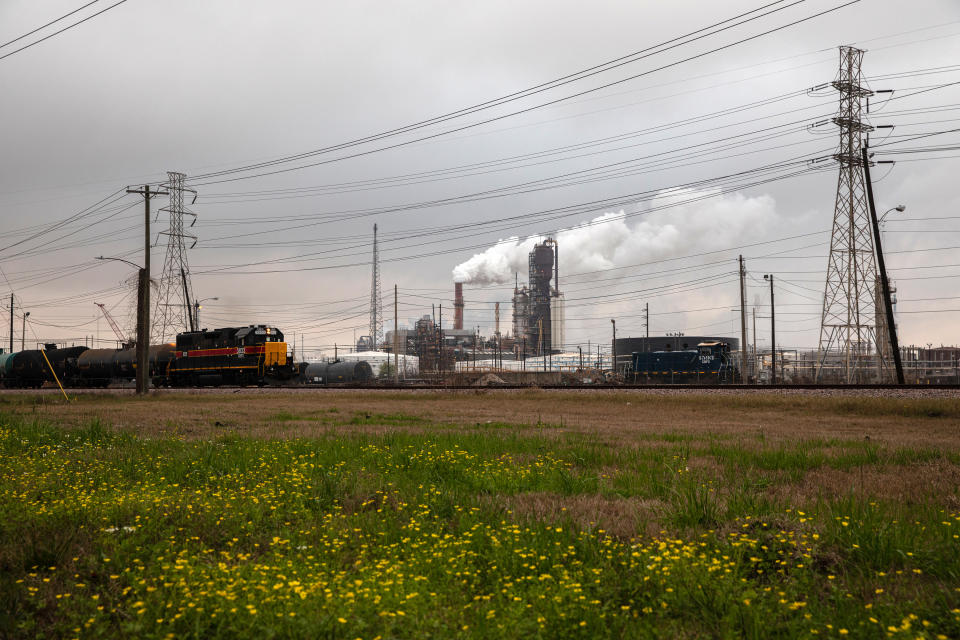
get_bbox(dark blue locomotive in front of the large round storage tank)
[631,341,740,384]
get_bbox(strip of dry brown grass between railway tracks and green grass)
[7,390,960,451]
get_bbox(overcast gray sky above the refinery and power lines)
[0,0,960,351]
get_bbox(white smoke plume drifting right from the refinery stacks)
[453,190,776,285]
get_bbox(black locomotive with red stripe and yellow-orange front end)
[166,324,299,387]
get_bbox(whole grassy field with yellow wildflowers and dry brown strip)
[0,391,960,639]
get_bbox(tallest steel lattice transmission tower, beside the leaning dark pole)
[816,47,889,384]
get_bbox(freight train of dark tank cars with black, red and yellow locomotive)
[0,325,300,389]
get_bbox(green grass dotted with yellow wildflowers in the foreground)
[0,412,960,638]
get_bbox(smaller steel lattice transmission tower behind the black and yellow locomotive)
[150,171,197,342]
